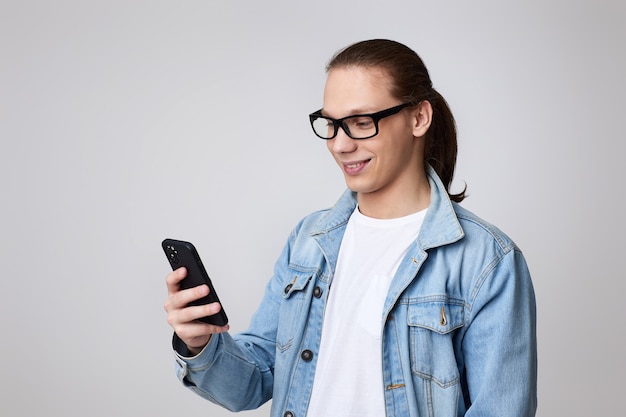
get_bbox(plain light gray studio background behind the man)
[0,0,626,416]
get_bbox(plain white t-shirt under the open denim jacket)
[307,207,426,417]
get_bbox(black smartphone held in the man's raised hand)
[161,239,228,326]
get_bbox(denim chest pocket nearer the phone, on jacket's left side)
[276,274,312,352]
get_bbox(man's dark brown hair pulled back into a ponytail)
[326,39,467,202]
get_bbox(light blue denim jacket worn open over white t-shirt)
[174,167,537,417]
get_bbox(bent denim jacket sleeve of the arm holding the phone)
[173,229,293,411]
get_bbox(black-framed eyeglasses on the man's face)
[309,102,417,140]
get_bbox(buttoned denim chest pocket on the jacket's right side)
[407,300,464,388]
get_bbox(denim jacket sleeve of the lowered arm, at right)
[463,248,537,417]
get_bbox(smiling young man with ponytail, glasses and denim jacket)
[165,40,537,417]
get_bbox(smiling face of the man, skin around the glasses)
[322,66,423,202]
